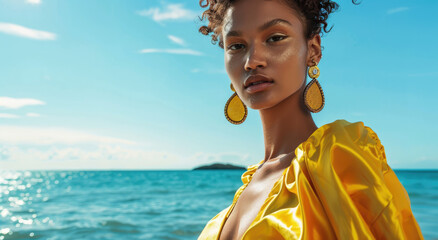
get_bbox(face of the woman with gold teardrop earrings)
[222,0,307,109]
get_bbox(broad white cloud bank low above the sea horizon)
[0,125,254,170]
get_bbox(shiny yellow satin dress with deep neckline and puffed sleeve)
[198,119,424,240]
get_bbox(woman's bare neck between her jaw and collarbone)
[259,82,318,161]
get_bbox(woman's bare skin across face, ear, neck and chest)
[220,0,322,239]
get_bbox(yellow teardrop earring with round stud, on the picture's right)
[304,59,324,113]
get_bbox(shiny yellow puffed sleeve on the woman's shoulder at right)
[286,119,423,239]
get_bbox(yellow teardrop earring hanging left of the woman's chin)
[224,84,248,124]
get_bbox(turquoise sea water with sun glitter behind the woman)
[0,170,438,240]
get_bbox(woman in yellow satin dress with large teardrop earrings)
[198,0,423,240]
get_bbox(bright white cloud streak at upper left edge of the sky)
[0,22,56,40]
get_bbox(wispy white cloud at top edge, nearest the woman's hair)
[138,4,197,22]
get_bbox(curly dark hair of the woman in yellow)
[199,0,359,49]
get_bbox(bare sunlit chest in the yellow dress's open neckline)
[219,172,281,240]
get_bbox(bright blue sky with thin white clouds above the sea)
[0,0,438,169]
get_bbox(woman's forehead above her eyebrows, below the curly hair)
[222,0,302,37]
